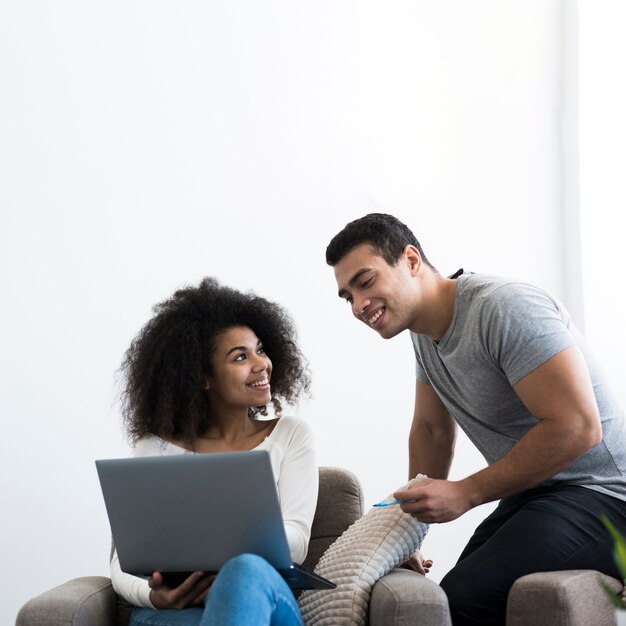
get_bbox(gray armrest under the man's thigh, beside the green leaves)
[506,570,623,626]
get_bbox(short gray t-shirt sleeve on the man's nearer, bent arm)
[483,283,576,385]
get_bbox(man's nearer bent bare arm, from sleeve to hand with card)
[395,346,602,522]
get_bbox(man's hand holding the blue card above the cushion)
[393,479,472,524]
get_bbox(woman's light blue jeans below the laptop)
[130,554,303,626]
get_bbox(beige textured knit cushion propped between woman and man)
[299,474,428,626]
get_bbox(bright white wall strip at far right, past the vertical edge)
[579,0,626,402]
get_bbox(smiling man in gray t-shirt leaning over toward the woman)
[326,214,626,626]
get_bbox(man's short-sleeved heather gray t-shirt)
[411,273,626,500]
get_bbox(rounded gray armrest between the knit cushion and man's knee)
[369,569,452,626]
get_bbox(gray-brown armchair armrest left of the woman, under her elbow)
[15,576,117,626]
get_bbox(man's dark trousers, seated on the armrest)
[441,485,626,626]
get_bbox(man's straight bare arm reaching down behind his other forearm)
[409,380,456,478]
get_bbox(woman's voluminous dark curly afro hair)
[120,278,310,444]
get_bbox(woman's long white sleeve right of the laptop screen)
[278,418,319,563]
